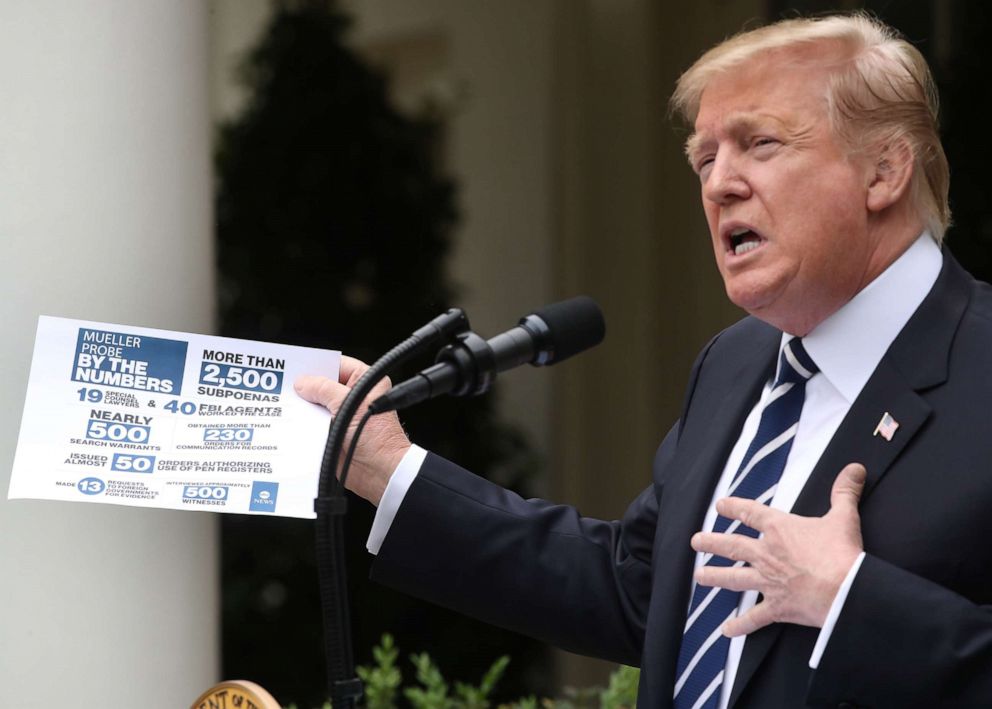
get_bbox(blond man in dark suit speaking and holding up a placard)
[297,16,992,709]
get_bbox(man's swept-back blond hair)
[671,13,951,243]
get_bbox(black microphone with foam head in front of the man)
[369,295,606,414]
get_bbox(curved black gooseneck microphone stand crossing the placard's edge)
[313,308,469,709]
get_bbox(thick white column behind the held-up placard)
[0,0,219,709]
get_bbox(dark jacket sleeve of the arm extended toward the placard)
[372,429,676,665]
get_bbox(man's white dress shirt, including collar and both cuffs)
[367,232,942,709]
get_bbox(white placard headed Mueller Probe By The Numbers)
[7,316,340,518]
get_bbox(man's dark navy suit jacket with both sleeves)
[373,255,992,709]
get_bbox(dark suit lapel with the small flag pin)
[730,253,968,707]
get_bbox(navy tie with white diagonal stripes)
[675,338,818,709]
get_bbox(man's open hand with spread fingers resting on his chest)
[692,463,866,637]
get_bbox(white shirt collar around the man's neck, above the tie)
[780,231,943,404]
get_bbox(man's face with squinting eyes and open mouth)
[689,52,888,335]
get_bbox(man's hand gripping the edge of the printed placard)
[293,356,410,505]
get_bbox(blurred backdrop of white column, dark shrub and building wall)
[0,0,992,708]
